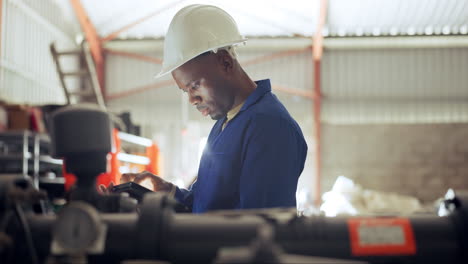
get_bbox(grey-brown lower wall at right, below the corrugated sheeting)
[322,124,468,201]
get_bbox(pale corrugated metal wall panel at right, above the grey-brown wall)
[323,47,468,123]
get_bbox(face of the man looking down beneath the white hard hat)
[172,53,234,120]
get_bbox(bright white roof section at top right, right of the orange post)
[328,0,468,36]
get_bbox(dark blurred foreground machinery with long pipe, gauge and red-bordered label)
[0,106,468,264]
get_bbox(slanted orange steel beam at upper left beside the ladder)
[70,0,106,96]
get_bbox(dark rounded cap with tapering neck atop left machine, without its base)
[51,105,112,184]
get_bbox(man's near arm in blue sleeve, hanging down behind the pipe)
[239,115,307,208]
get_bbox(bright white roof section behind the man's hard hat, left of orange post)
[82,0,318,38]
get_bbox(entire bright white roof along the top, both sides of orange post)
[82,0,468,39]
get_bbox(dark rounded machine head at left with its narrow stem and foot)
[51,105,136,212]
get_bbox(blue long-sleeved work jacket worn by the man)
[175,80,307,213]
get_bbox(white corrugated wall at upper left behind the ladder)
[0,0,78,104]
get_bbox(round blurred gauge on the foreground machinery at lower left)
[51,202,107,255]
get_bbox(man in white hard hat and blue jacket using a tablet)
[113,5,307,213]
